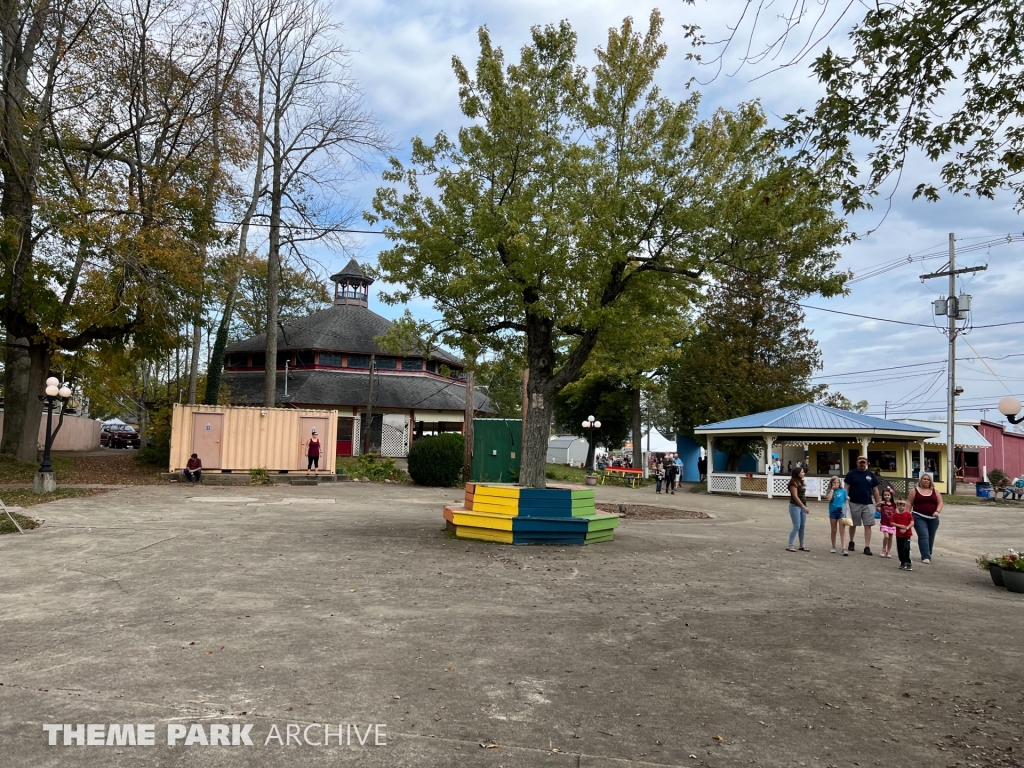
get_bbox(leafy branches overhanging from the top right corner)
[687,0,1024,211]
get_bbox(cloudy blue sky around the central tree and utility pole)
[315,0,1024,428]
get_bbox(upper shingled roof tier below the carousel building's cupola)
[225,303,462,367]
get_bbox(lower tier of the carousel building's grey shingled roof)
[221,371,494,413]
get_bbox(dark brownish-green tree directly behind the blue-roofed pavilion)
[668,284,824,469]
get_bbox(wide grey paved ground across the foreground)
[0,484,1024,768]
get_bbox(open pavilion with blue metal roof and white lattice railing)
[693,402,945,498]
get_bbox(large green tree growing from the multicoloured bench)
[368,11,843,487]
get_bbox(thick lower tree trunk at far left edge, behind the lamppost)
[0,336,50,462]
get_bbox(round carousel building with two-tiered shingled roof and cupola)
[223,259,492,457]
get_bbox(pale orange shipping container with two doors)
[170,403,338,474]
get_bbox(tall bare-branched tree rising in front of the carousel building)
[254,0,390,406]
